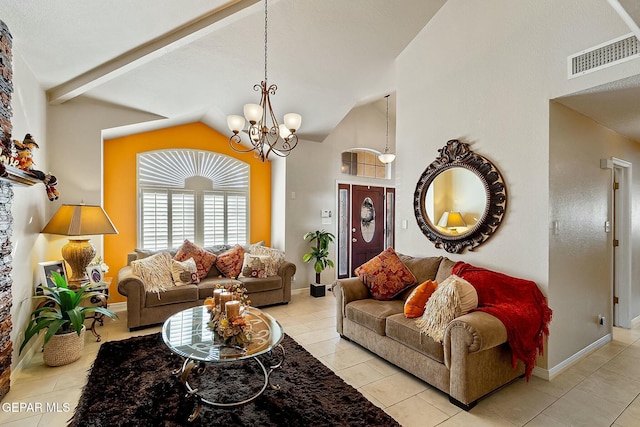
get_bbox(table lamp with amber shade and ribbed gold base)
[41,203,118,288]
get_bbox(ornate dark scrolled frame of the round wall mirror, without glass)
[413,139,507,253]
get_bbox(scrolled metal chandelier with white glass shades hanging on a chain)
[227,0,302,162]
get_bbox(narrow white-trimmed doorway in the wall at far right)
[611,157,632,328]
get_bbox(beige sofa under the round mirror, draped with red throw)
[333,254,525,410]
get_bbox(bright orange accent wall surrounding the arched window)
[103,122,271,302]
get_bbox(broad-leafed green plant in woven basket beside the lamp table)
[19,271,118,366]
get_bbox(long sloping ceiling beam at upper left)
[46,0,260,104]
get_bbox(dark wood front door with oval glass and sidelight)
[337,184,395,279]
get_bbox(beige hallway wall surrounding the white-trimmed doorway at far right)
[549,102,640,366]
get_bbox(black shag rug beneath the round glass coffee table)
[70,334,399,427]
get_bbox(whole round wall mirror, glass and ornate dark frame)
[413,139,507,253]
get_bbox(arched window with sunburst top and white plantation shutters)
[137,149,249,250]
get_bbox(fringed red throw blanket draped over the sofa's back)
[452,262,552,381]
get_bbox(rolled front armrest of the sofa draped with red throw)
[443,311,507,369]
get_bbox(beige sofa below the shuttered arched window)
[118,252,296,330]
